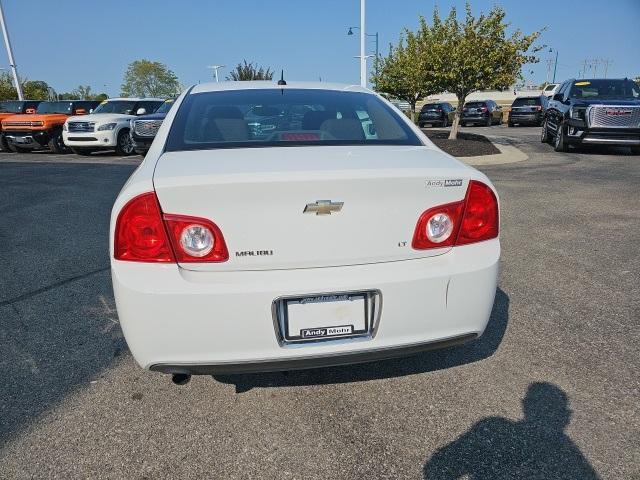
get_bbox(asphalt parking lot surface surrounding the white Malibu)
[0,126,640,479]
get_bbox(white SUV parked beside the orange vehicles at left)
[62,98,164,155]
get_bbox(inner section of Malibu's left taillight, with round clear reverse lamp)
[164,214,229,263]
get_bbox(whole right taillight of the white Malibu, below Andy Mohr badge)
[411,180,499,250]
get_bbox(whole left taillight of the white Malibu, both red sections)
[113,192,229,263]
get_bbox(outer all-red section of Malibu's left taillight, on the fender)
[113,192,175,262]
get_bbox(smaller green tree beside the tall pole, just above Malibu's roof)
[372,23,442,121]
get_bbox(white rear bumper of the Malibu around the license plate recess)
[112,239,500,373]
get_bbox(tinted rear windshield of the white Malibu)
[166,88,422,151]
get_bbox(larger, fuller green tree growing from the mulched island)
[429,3,542,140]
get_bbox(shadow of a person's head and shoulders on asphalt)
[424,383,599,480]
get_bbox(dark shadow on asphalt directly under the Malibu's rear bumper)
[213,288,509,393]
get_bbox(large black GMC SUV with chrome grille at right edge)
[540,78,640,154]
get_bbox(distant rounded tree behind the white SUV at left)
[120,59,181,97]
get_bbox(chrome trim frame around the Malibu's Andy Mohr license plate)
[271,289,382,348]
